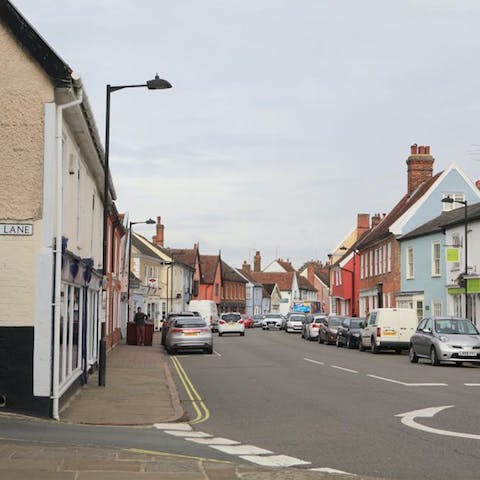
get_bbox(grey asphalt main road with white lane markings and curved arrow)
[172,330,480,479]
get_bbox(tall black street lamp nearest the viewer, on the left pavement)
[98,74,172,387]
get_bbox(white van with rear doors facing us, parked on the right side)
[359,308,418,353]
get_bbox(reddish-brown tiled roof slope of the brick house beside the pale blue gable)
[356,172,442,248]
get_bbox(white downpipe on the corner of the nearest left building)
[52,87,83,420]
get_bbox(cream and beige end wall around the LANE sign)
[0,24,54,326]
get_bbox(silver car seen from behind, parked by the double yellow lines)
[165,316,213,355]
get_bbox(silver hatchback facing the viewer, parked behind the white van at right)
[410,317,480,366]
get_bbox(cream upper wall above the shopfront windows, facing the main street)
[62,123,103,268]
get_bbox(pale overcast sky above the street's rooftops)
[12,0,480,268]
